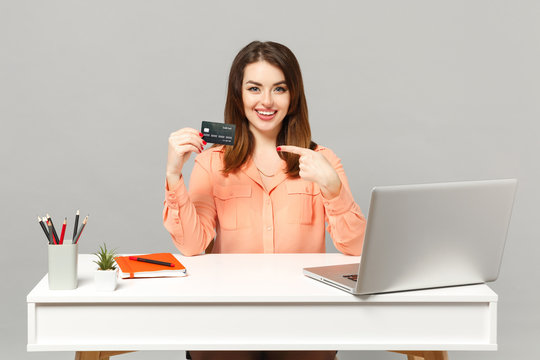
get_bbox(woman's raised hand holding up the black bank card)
[167,128,206,186]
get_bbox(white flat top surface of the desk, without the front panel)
[27,254,497,303]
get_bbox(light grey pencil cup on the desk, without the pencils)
[49,240,79,290]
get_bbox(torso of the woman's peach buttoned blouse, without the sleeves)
[190,147,339,253]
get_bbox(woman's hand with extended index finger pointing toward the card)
[277,145,341,200]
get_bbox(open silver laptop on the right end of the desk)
[304,179,517,295]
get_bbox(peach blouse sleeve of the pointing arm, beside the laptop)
[321,148,366,256]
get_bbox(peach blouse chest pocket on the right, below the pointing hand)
[287,180,320,225]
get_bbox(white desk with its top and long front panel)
[27,254,497,358]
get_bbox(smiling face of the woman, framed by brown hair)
[242,61,291,136]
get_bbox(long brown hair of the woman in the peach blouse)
[223,41,317,177]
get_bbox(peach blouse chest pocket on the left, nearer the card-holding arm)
[213,184,251,230]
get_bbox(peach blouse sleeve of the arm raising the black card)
[163,153,216,256]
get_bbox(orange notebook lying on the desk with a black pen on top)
[114,253,186,279]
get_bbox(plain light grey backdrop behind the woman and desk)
[0,0,540,359]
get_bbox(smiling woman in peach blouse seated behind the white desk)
[163,41,366,360]
